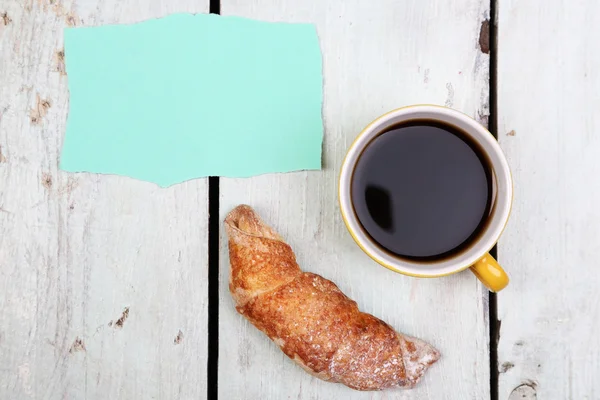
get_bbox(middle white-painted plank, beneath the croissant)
[219,0,489,400]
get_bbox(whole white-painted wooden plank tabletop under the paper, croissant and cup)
[0,0,600,400]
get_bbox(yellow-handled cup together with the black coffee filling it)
[339,105,513,292]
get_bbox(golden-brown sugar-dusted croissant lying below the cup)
[225,205,439,390]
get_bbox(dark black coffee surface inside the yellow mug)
[351,121,493,258]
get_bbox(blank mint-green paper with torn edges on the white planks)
[60,14,323,186]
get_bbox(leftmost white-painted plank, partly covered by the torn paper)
[0,0,208,399]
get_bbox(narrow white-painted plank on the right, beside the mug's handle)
[498,0,600,399]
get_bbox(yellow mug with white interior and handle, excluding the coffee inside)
[339,105,513,292]
